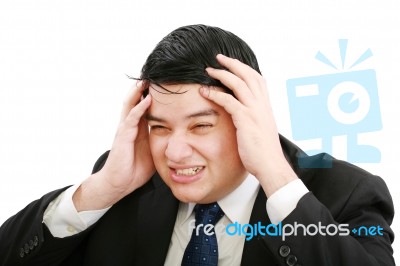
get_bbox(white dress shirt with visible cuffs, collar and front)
[43,175,308,266]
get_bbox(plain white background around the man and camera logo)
[0,0,400,262]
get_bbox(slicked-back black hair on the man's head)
[139,24,261,95]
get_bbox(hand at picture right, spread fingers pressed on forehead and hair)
[200,55,297,196]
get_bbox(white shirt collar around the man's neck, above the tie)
[181,174,260,224]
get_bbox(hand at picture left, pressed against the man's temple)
[72,82,155,212]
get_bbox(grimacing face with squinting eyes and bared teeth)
[146,84,247,203]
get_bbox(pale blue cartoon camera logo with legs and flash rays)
[286,39,382,168]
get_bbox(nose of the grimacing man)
[165,134,193,163]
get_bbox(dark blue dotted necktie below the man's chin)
[182,202,224,266]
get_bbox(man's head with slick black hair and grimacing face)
[141,25,260,203]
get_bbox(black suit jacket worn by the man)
[0,137,394,266]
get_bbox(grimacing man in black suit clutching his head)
[0,25,394,266]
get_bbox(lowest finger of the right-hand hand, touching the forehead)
[200,87,243,116]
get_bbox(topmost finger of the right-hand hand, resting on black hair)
[217,54,266,96]
